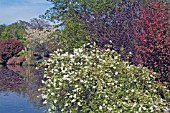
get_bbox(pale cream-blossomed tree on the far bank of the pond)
[24,27,59,63]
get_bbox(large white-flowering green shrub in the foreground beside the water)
[41,44,170,113]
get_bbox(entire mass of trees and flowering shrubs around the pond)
[0,0,170,113]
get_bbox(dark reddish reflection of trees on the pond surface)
[0,65,43,107]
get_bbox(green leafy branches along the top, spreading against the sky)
[40,0,121,25]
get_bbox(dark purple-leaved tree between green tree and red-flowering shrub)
[80,0,140,62]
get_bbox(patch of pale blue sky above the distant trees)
[0,0,52,25]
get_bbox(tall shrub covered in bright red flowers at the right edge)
[134,0,170,82]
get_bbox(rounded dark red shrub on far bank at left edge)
[0,38,23,63]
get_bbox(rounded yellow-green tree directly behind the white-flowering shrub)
[60,17,90,51]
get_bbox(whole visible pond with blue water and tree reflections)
[0,65,46,113]
